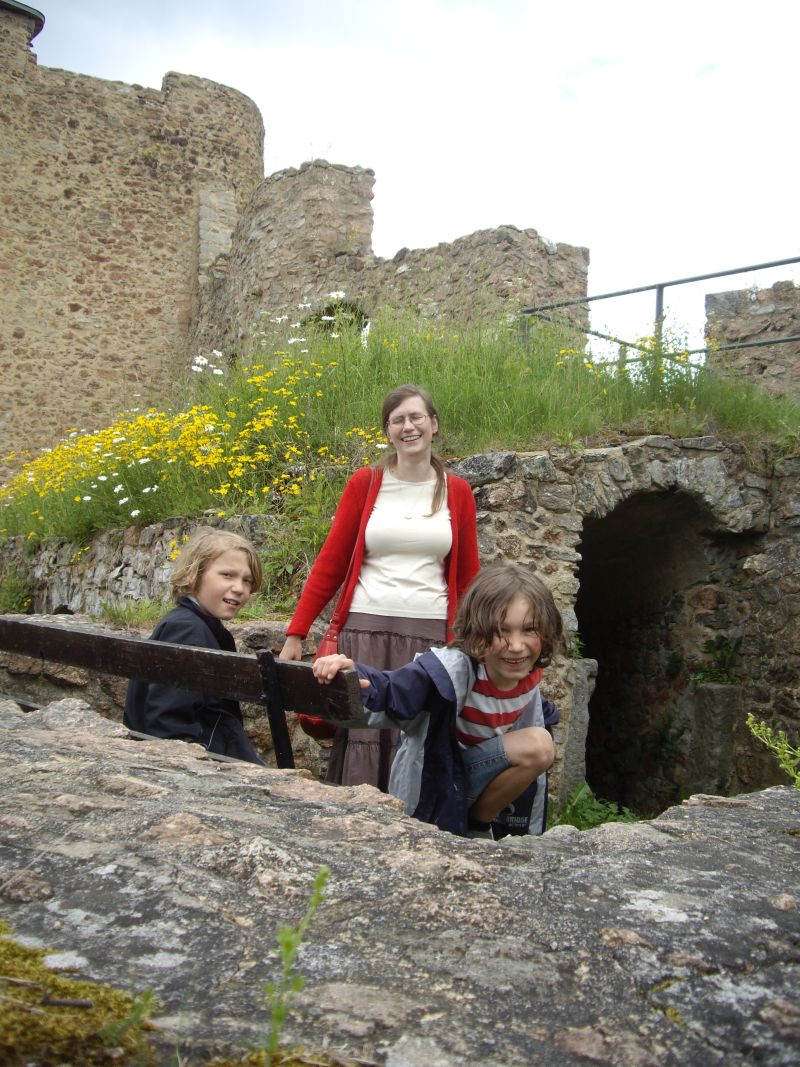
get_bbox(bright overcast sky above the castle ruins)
[27,0,800,347]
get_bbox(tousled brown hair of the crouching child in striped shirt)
[451,563,566,667]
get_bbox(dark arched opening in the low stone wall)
[576,489,757,814]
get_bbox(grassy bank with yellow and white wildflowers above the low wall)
[0,293,800,610]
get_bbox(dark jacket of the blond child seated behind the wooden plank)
[123,596,263,764]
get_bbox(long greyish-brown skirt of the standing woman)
[325,611,447,793]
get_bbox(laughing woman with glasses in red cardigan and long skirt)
[281,385,480,792]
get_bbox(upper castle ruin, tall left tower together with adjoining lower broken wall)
[0,3,588,469]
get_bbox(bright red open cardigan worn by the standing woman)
[286,467,480,637]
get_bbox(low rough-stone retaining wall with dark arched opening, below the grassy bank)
[3,436,800,811]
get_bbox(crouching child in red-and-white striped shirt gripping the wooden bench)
[314,563,564,838]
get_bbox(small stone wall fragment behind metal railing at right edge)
[705,282,800,398]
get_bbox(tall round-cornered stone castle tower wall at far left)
[0,7,263,469]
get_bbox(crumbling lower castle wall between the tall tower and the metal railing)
[187,159,589,351]
